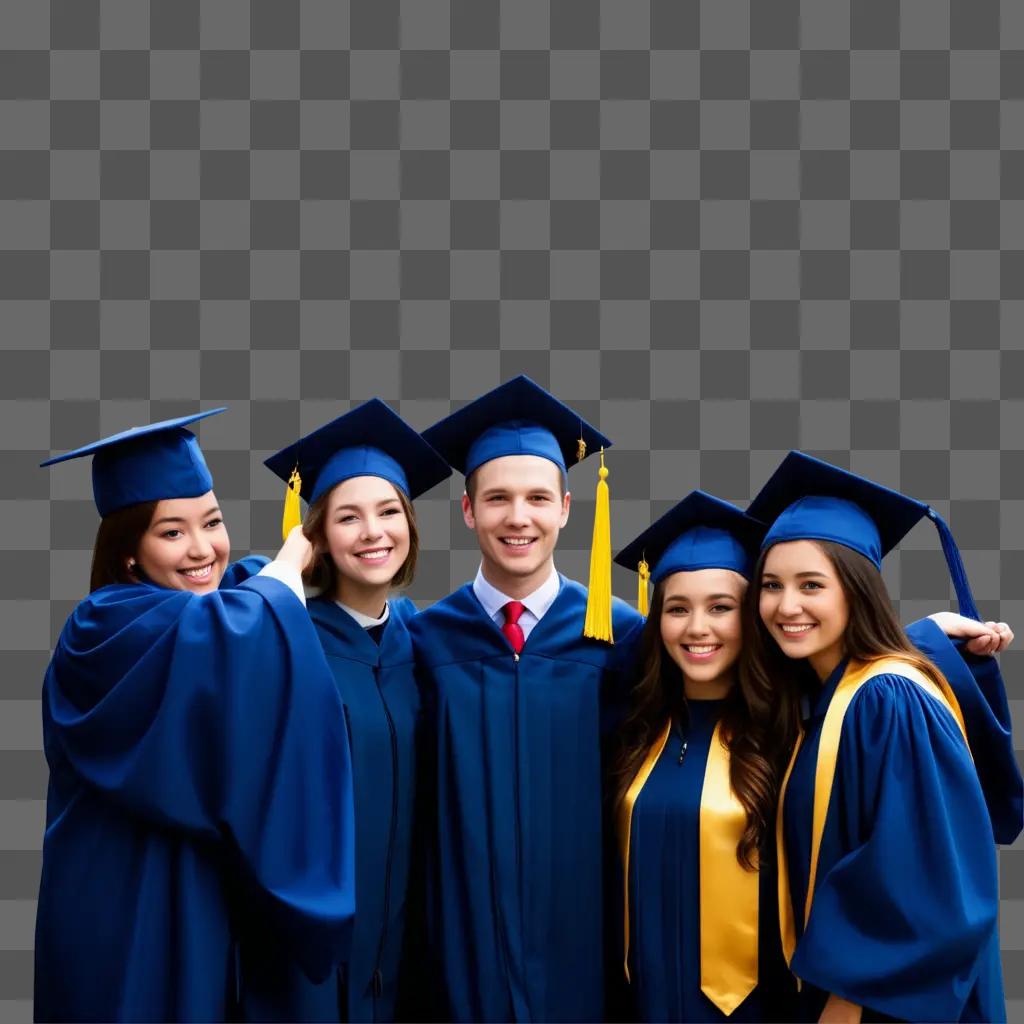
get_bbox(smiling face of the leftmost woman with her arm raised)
[135,490,231,594]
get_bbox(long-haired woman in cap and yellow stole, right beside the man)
[612,490,794,1021]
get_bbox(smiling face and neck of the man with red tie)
[462,455,570,596]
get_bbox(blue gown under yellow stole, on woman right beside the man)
[620,700,796,1021]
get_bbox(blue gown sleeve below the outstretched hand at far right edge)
[906,618,1024,844]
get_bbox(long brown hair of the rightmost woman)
[739,540,943,765]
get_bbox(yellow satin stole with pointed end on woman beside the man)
[615,722,758,1016]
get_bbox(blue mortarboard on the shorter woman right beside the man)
[615,490,765,584]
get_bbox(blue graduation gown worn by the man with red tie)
[412,578,642,1021]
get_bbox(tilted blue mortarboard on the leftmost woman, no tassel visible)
[40,408,224,516]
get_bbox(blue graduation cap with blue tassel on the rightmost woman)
[746,452,980,618]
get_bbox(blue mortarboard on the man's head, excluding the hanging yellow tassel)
[423,375,611,476]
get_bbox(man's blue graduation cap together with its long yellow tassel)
[423,375,613,642]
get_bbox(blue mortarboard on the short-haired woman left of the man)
[264,398,452,504]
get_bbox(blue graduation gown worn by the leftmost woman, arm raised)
[35,560,354,1021]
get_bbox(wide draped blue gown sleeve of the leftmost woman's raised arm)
[43,565,354,980]
